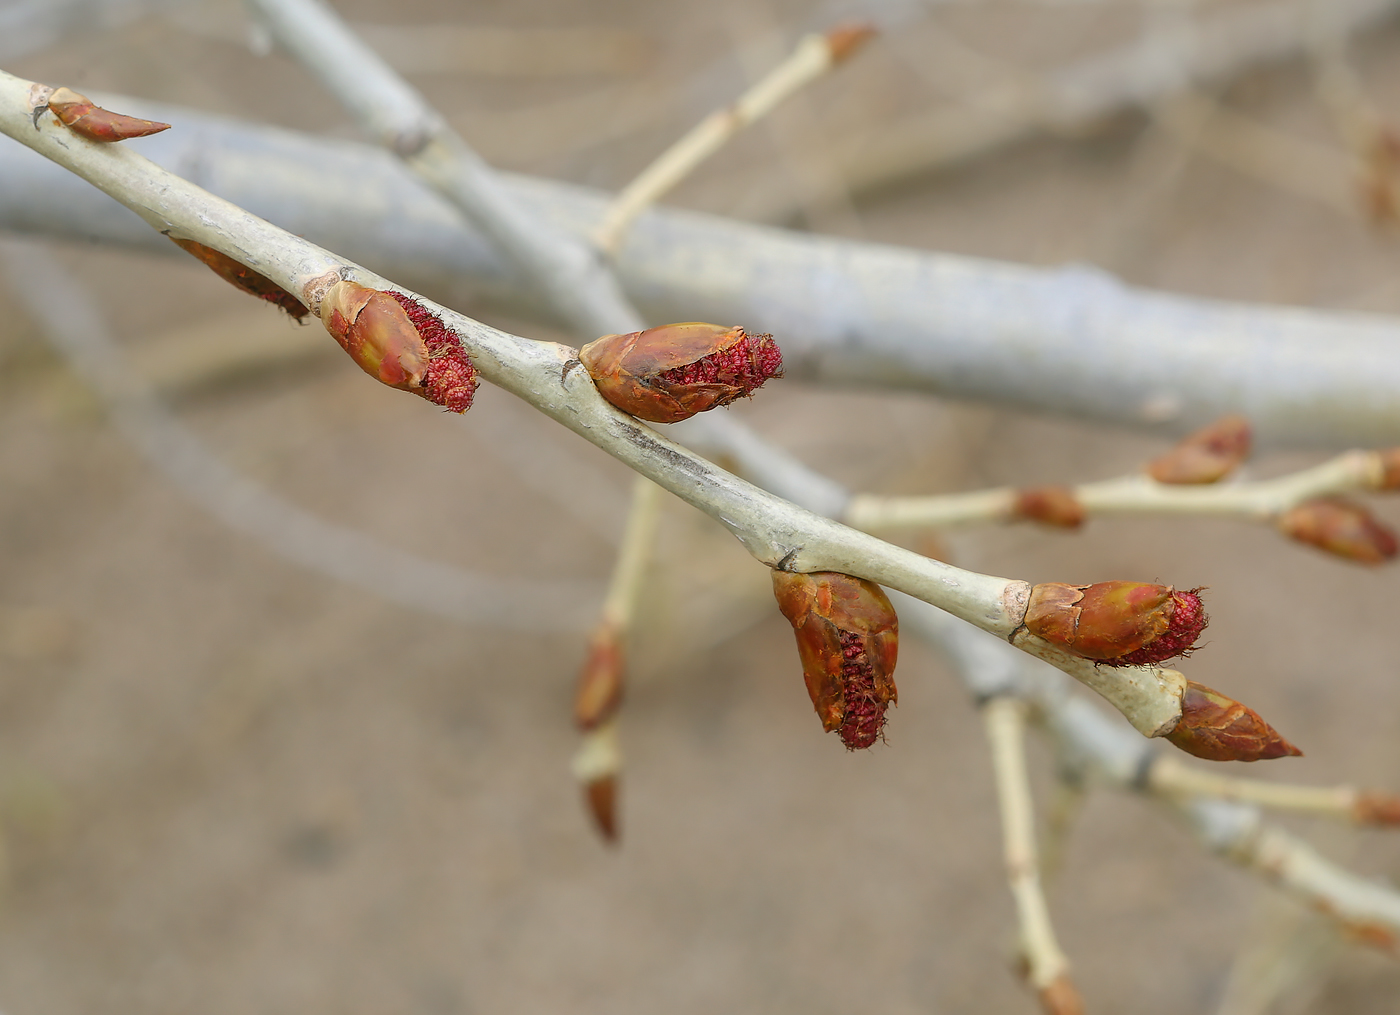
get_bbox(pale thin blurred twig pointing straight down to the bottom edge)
[983,697,1082,1015]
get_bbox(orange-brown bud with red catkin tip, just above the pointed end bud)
[1025,581,1208,666]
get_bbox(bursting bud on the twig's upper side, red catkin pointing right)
[578,322,783,423]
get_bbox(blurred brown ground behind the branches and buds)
[0,0,1400,1015]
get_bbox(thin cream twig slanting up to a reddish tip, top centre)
[594,25,874,255]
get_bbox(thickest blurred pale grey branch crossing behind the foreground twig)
[8,97,1400,449]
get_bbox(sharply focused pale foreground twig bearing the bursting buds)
[0,73,1184,734]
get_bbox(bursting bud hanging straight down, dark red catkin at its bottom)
[773,571,899,750]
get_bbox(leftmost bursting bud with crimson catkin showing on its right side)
[321,281,476,413]
